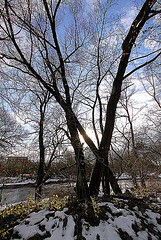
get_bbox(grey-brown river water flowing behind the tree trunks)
[0,179,161,206]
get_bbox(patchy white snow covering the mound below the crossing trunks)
[11,199,161,240]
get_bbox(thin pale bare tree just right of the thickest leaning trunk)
[115,88,146,188]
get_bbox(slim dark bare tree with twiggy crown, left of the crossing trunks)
[20,83,64,199]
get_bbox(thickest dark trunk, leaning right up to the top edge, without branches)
[90,0,156,197]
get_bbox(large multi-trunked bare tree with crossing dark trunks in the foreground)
[0,0,161,208]
